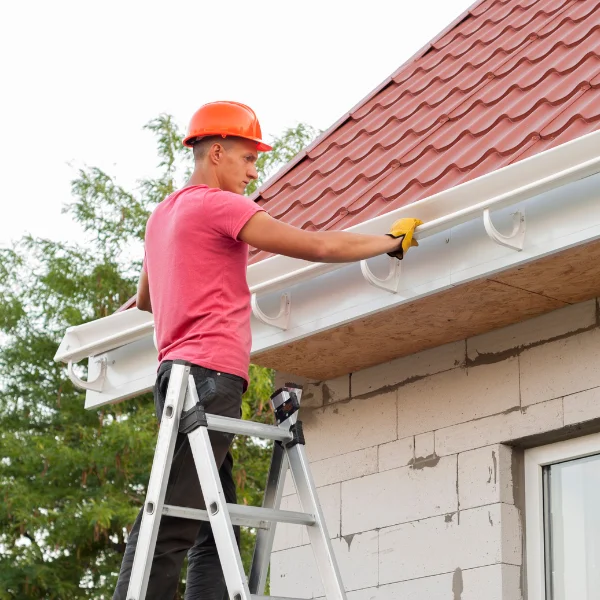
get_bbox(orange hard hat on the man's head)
[183,101,272,152]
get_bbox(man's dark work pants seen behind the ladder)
[113,361,244,600]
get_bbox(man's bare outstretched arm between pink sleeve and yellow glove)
[238,211,402,263]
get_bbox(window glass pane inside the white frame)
[544,455,600,600]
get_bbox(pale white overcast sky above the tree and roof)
[0,0,472,245]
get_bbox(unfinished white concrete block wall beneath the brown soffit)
[271,300,600,600]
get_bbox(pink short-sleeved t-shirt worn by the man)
[144,185,263,381]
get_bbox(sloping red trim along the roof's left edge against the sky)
[250,0,488,202]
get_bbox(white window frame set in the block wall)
[525,433,600,600]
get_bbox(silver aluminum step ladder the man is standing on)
[127,361,346,600]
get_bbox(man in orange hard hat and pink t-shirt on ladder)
[113,102,421,600]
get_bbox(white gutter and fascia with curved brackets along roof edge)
[55,132,600,408]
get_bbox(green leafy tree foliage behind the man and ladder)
[0,115,315,600]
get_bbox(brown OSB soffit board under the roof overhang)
[252,242,600,380]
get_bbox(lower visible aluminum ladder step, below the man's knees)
[163,503,315,529]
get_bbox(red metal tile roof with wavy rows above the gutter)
[251,0,600,262]
